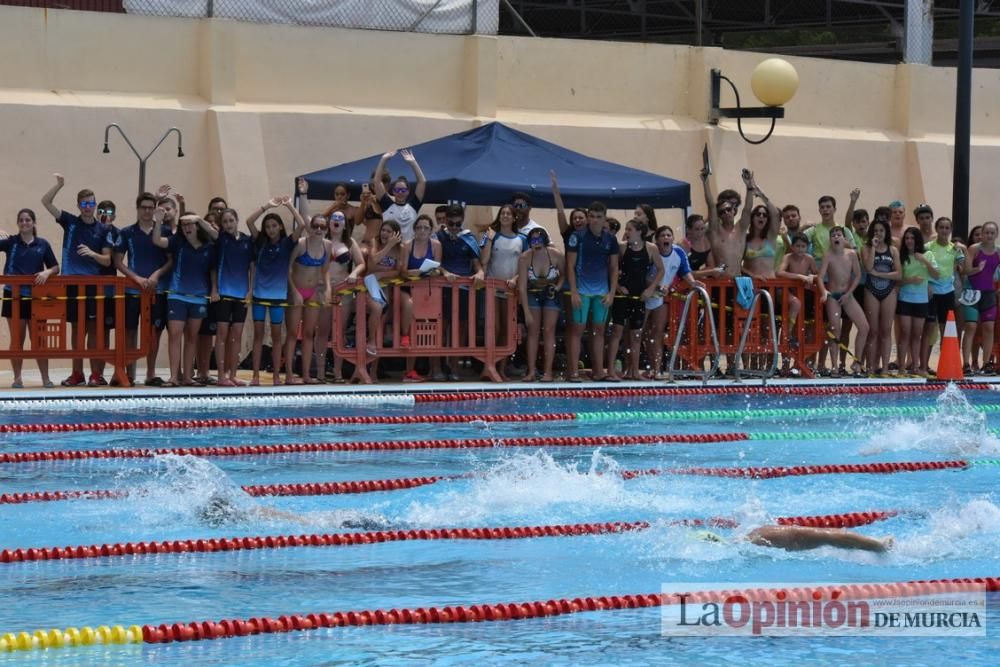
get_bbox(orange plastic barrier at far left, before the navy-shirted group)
[0,276,156,387]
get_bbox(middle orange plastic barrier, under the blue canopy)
[333,278,517,384]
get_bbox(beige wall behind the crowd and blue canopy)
[0,7,1000,354]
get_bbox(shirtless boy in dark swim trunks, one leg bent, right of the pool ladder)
[816,226,868,377]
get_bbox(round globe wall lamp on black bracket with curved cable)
[709,58,799,144]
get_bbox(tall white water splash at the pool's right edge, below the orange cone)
[858,384,1000,456]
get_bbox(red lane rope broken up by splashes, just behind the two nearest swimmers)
[0,459,1000,505]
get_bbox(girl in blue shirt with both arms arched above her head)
[247,197,305,386]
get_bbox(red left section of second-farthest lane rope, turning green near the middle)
[0,412,576,433]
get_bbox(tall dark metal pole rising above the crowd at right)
[951,0,975,242]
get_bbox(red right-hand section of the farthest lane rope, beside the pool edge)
[413,382,990,403]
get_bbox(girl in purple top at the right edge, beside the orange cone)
[962,222,1000,374]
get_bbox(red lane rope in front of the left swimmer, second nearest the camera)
[0,510,899,563]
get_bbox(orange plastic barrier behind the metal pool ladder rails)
[664,278,827,377]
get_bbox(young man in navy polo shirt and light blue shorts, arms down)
[566,202,619,382]
